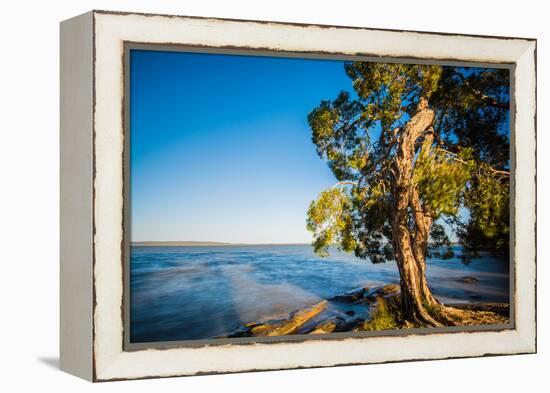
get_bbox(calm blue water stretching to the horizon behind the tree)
[130,245,509,342]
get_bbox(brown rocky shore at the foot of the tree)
[225,277,509,338]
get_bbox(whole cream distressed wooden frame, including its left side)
[60,11,536,381]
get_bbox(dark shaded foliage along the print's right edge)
[430,67,510,252]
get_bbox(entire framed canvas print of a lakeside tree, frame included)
[60,11,536,381]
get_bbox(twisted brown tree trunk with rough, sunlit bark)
[391,98,462,326]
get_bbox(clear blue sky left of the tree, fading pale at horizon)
[130,50,352,243]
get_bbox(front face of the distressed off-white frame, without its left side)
[62,12,536,380]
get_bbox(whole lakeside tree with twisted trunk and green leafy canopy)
[307,62,509,326]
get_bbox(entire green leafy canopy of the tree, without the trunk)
[307,62,509,263]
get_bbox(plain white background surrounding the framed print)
[0,0,550,393]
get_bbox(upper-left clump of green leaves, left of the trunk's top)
[308,62,442,180]
